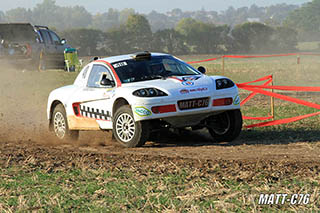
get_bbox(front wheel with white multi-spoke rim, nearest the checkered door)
[112,105,150,147]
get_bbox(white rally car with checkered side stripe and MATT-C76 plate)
[47,52,242,147]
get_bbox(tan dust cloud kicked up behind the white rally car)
[0,61,111,145]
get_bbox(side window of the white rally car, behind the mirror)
[87,64,114,88]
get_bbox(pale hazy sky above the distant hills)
[0,0,311,13]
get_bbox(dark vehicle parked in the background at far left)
[0,23,70,69]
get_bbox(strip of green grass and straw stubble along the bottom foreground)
[0,167,320,212]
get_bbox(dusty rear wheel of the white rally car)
[51,104,79,141]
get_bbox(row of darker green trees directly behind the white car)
[60,14,298,55]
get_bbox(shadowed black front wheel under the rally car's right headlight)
[207,109,242,142]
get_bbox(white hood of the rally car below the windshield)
[123,75,214,95]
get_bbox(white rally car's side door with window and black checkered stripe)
[79,64,116,129]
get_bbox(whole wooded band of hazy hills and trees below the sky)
[0,0,320,55]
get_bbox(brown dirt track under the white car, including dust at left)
[0,64,320,170]
